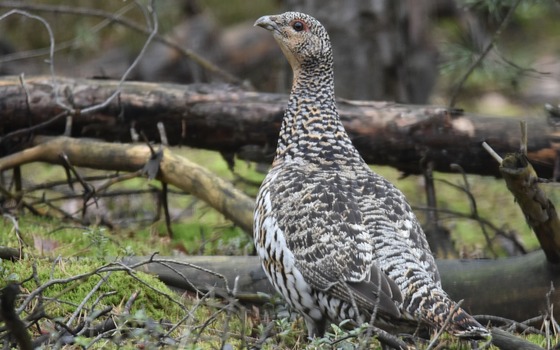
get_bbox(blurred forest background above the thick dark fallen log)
[0,0,560,110]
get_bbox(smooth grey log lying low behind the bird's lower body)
[124,252,560,322]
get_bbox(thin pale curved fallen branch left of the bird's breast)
[0,136,255,234]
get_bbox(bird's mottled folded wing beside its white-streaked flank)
[274,171,402,316]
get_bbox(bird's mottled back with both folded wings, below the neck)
[259,152,440,313]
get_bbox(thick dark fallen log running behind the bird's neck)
[0,77,558,178]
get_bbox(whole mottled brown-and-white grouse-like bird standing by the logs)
[253,12,490,339]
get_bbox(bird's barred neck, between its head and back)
[274,67,363,170]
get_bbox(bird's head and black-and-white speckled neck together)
[258,12,361,165]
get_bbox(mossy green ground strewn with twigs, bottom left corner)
[0,253,258,349]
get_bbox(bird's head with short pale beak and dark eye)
[255,12,332,72]
